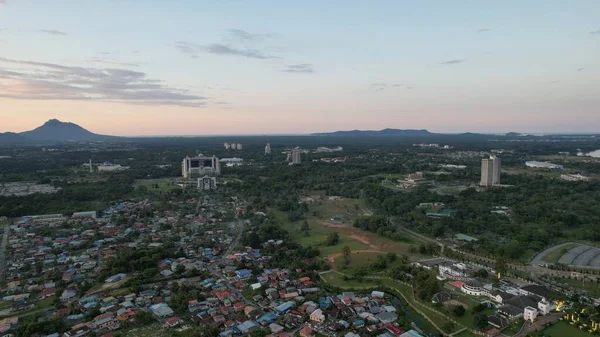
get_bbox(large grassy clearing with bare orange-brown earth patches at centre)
[271,196,424,259]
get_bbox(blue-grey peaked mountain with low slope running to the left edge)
[0,119,119,144]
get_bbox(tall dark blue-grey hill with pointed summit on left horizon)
[19,119,117,141]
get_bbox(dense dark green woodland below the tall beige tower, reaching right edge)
[355,175,600,259]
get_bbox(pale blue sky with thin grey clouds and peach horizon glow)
[0,0,600,136]
